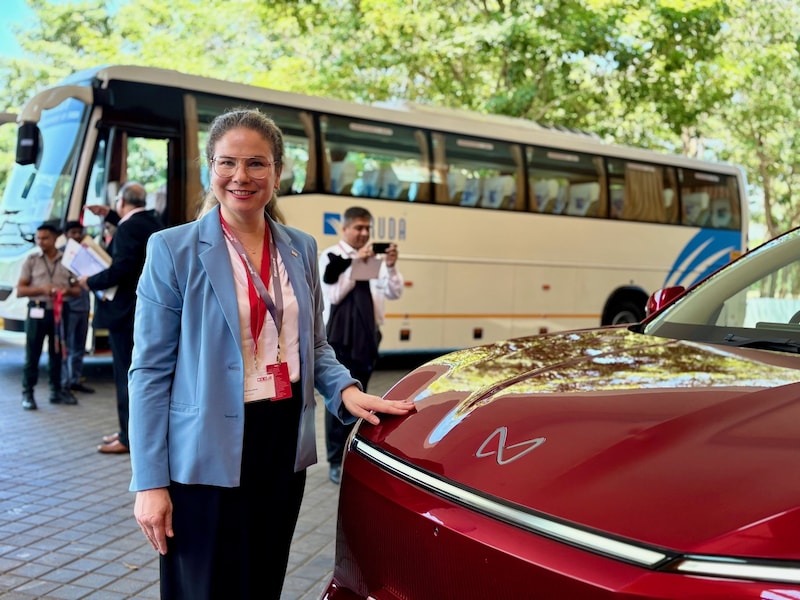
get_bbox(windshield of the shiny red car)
[641,230,800,352]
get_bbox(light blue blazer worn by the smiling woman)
[128,207,357,491]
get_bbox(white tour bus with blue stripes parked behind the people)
[0,66,748,353]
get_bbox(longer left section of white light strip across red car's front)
[350,437,676,569]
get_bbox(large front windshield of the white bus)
[0,99,87,256]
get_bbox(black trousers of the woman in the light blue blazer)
[160,384,306,600]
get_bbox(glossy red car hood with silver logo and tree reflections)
[370,328,800,558]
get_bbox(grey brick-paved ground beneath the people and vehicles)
[0,340,407,600]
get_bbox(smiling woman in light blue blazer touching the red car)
[129,110,413,600]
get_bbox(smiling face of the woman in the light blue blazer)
[211,127,280,221]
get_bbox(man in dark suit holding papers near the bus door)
[80,181,162,454]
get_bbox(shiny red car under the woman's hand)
[323,226,800,600]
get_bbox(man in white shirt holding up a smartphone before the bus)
[319,206,403,484]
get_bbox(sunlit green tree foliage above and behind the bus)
[0,0,800,244]
